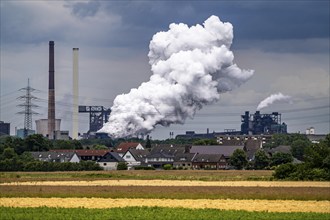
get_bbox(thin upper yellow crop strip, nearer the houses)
[0,180,330,187]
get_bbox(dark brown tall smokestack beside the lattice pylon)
[48,41,55,139]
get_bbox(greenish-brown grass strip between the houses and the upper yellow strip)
[0,170,272,182]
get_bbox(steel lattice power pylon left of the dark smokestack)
[17,79,39,137]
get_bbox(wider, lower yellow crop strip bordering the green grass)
[0,198,330,213]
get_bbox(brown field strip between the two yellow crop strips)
[0,186,330,200]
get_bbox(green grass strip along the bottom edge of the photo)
[0,207,329,220]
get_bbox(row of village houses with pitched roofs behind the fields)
[32,140,268,170]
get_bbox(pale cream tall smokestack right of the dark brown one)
[72,48,79,139]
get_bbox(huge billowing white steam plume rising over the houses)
[100,16,253,138]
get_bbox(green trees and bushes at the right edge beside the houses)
[230,134,330,180]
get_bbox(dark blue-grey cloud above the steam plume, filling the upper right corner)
[102,1,329,39]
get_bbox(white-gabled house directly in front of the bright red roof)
[123,148,150,169]
